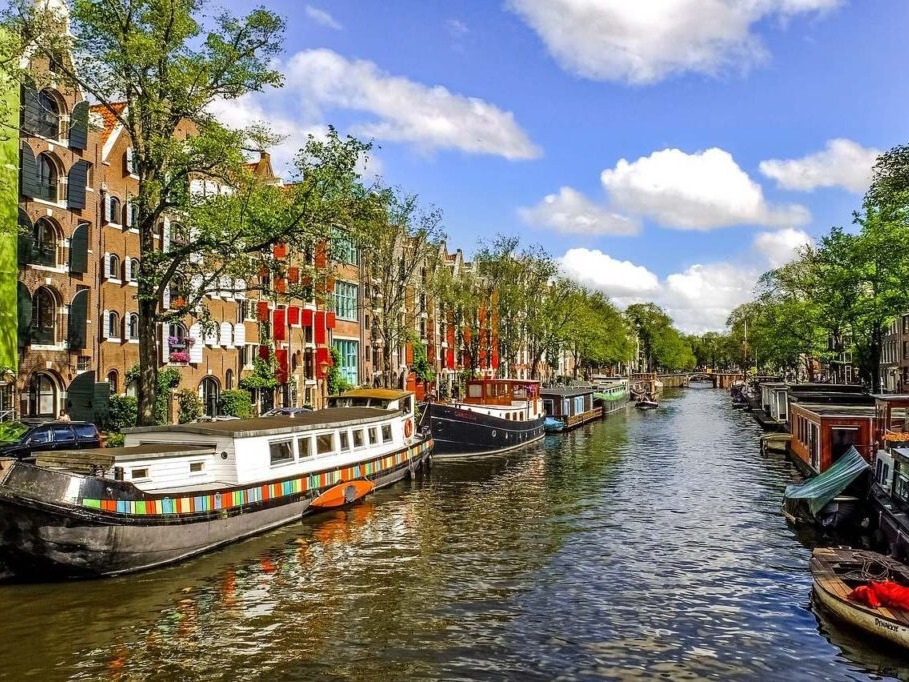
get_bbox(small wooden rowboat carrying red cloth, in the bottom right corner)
[811,547,909,647]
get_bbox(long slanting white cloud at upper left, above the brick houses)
[282,50,541,160]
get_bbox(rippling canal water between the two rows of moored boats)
[0,389,909,680]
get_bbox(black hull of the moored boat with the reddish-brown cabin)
[429,403,545,457]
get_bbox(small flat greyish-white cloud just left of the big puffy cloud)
[518,187,640,235]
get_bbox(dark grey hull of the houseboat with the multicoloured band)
[0,441,432,579]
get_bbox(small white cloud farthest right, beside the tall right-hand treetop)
[760,138,881,193]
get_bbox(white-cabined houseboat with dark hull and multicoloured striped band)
[0,391,432,577]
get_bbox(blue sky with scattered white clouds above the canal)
[215,0,909,331]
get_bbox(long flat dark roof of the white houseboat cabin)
[123,407,397,438]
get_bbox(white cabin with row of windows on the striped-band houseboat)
[117,407,419,493]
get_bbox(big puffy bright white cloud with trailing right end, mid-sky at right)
[601,148,811,230]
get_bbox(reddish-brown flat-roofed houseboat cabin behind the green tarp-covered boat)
[789,400,875,475]
